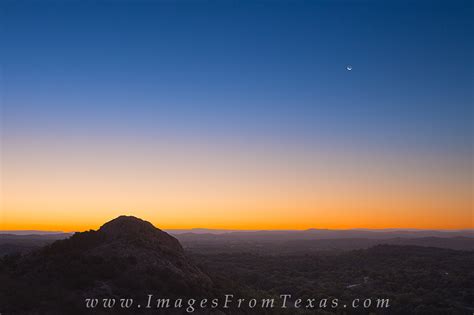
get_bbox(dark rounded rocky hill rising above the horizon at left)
[0,216,214,314]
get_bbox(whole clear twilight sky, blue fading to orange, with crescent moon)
[0,0,474,231]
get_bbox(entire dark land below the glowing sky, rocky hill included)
[0,216,474,315]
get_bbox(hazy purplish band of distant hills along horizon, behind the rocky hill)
[0,229,474,255]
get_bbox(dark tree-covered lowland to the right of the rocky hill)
[193,245,474,314]
